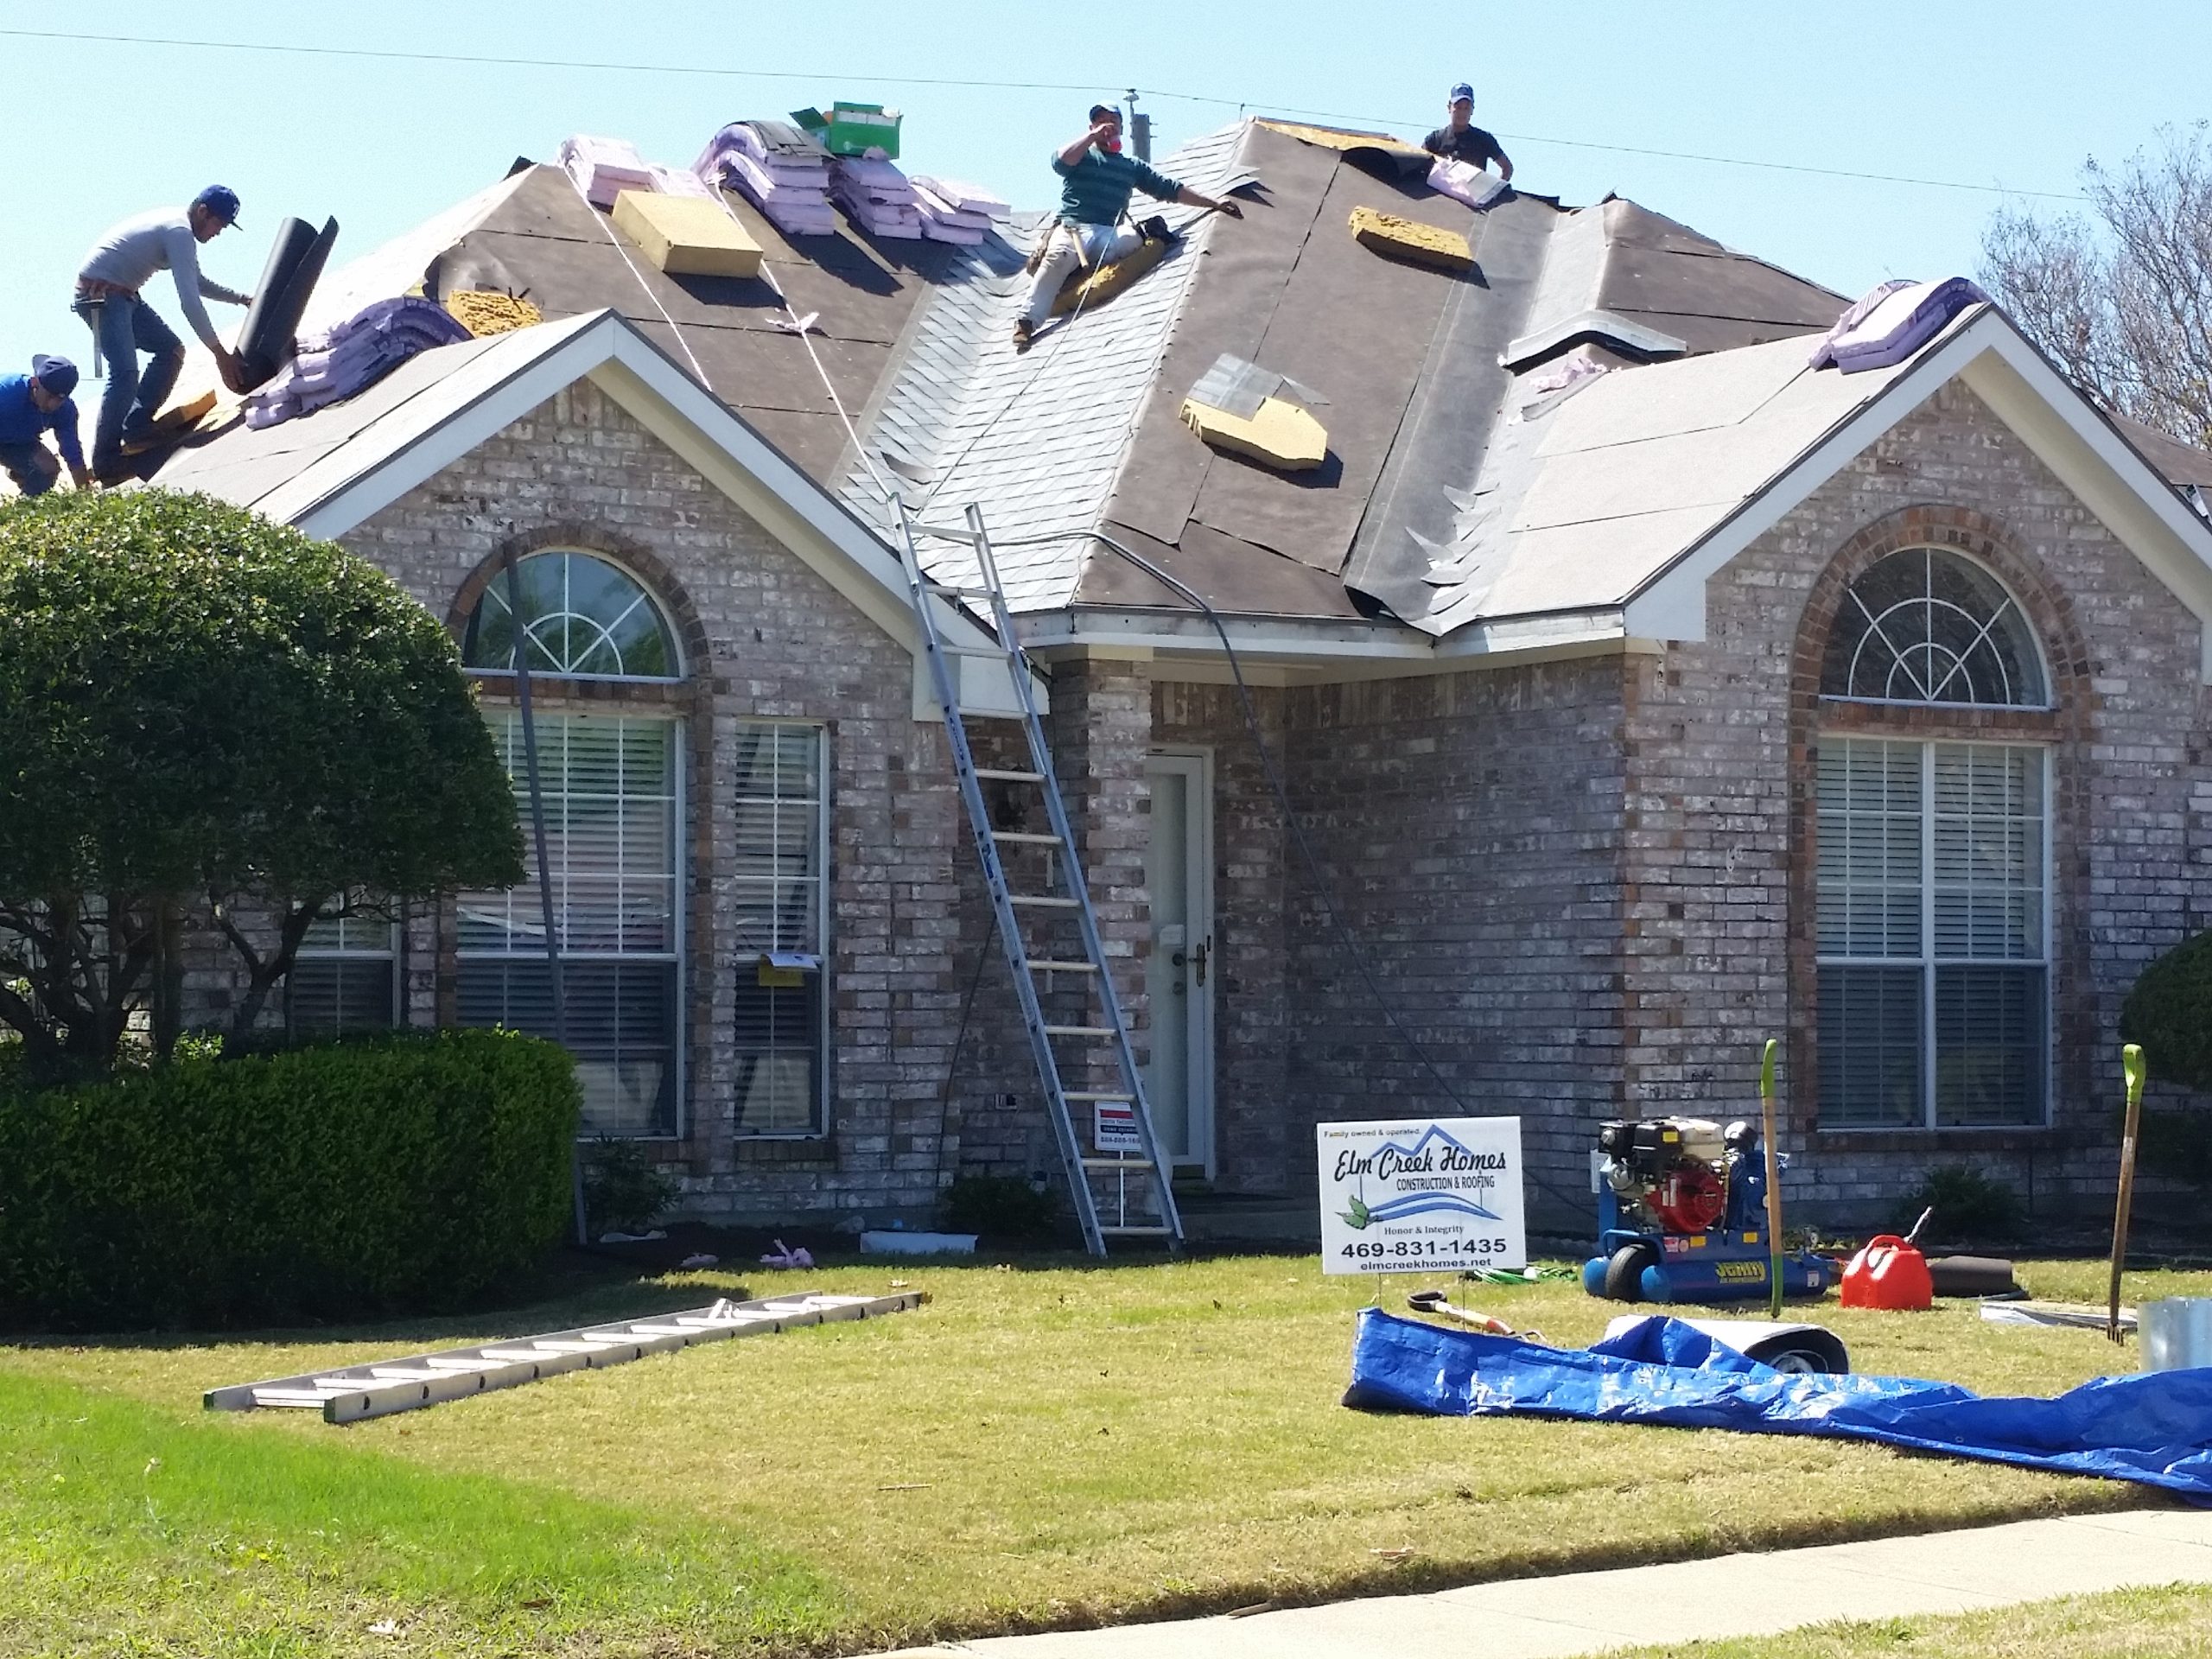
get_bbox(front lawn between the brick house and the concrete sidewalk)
[0,1256,2212,1659]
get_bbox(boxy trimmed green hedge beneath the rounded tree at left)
[0,1031,580,1330]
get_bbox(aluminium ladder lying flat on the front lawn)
[204,1289,929,1422]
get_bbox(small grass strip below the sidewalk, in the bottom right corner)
[1611,1584,2212,1659]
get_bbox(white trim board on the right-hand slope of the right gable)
[1960,329,2212,683]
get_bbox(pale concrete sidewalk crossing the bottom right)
[871,1509,2212,1659]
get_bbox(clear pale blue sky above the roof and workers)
[0,0,2212,382]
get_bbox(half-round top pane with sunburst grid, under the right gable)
[1821,546,2050,708]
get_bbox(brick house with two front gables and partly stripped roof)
[133,122,2212,1228]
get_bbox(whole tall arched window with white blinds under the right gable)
[1814,546,2053,1128]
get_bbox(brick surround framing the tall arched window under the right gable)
[1789,502,2101,1154]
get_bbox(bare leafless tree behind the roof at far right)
[1982,122,2212,447]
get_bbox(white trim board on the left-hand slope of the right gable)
[1621,309,2011,639]
